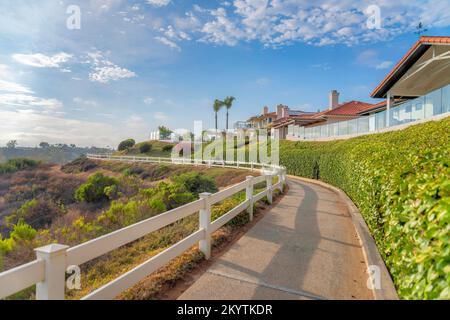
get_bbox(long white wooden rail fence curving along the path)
[0,155,286,300]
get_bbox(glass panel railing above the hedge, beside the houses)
[288,85,450,140]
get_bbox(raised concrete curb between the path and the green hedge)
[288,175,399,300]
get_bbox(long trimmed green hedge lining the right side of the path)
[280,118,450,299]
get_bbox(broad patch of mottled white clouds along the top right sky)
[156,0,450,47]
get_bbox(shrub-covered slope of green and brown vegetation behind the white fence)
[0,158,268,299]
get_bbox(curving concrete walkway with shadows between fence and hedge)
[179,180,373,300]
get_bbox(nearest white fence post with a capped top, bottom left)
[35,244,69,300]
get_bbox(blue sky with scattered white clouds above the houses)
[0,0,450,146]
